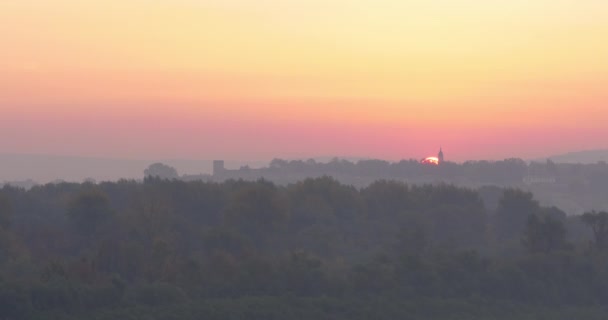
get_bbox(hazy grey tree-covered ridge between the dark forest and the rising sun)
[158,158,608,214]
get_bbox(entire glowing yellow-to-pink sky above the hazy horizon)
[0,0,608,161]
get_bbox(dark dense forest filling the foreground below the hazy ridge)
[0,178,608,320]
